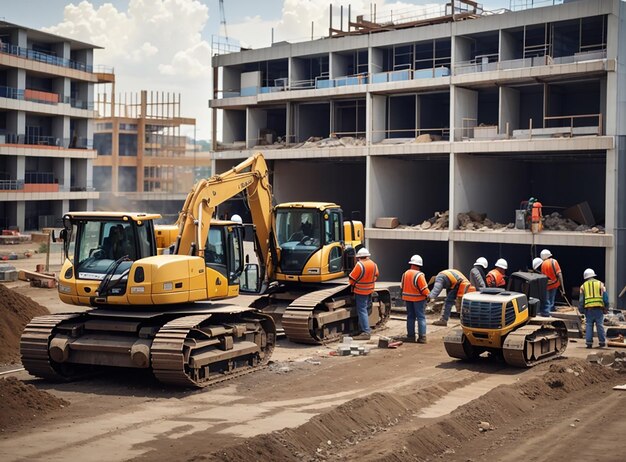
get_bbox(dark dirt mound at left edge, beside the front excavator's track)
[0,284,50,364]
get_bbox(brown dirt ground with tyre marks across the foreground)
[0,240,626,461]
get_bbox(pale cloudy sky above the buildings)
[0,0,512,140]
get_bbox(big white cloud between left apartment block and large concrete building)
[45,0,211,138]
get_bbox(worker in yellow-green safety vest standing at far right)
[578,268,609,348]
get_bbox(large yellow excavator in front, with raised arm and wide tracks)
[20,154,388,387]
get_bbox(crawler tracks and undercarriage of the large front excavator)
[20,306,276,387]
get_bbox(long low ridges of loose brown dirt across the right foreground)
[189,360,619,462]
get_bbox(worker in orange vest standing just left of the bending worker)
[402,255,430,343]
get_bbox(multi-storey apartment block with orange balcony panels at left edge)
[0,21,108,231]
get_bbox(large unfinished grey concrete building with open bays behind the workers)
[210,0,626,308]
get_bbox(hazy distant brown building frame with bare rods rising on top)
[94,91,205,221]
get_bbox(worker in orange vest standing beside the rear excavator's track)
[348,247,378,340]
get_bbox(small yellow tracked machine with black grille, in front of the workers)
[444,272,568,367]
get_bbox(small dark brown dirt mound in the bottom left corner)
[0,377,69,431]
